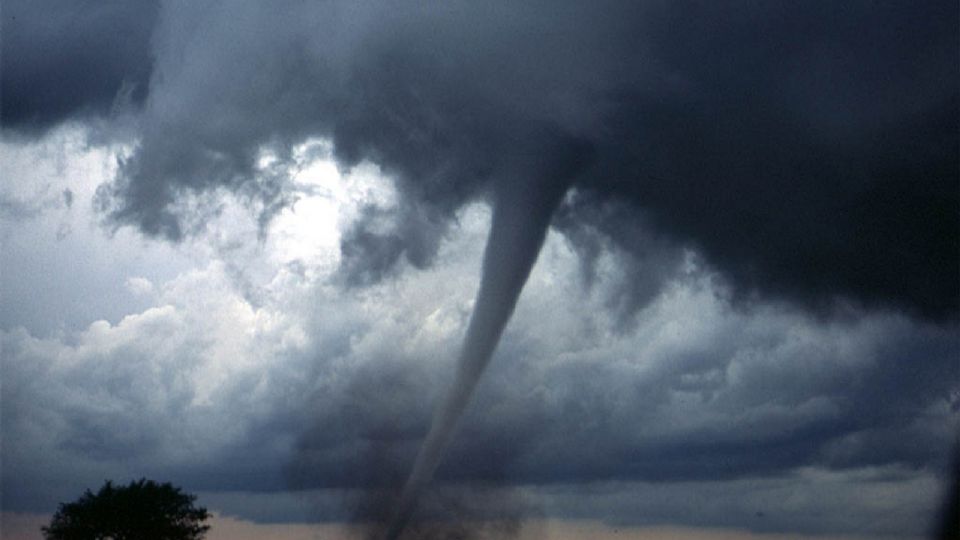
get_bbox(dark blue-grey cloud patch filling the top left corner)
[0,0,159,134]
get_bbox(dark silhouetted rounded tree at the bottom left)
[41,479,210,540]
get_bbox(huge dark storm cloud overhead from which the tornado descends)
[20,1,944,319]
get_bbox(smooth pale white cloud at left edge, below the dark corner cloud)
[0,126,192,336]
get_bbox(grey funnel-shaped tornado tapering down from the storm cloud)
[384,147,579,540]
